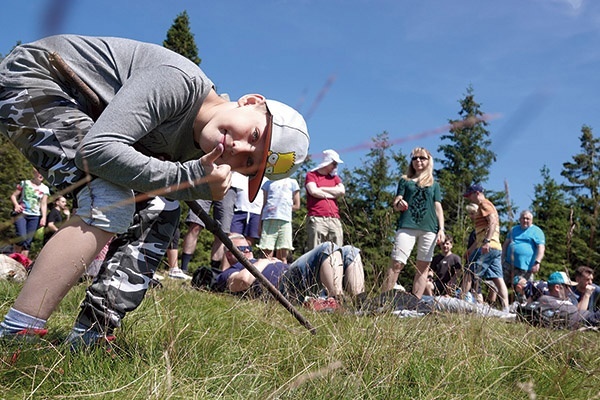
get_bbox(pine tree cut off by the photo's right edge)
[561,125,600,266]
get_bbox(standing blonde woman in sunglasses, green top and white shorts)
[381,147,445,298]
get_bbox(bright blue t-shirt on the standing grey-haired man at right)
[504,225,546,271]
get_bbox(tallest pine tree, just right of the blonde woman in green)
[436,86,502,250]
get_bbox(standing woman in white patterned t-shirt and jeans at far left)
[10,168,50,257]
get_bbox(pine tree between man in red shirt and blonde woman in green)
[340,132,408,284]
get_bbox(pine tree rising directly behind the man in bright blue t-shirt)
[531,166,570,278]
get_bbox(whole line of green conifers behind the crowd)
[0,11,600,286]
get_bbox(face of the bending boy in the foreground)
[200,99,271,176]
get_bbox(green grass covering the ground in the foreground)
[0,281,600,399]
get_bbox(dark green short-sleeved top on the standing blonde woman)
[396,178,442,233]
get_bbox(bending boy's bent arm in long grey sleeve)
[75,67,220,200]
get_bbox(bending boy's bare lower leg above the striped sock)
[13,216,113,319]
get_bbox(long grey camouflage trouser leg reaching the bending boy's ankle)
[77,197,181,334]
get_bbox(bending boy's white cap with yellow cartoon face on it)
[248,100,310,202]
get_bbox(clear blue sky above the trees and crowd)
[0,0,600,216]
